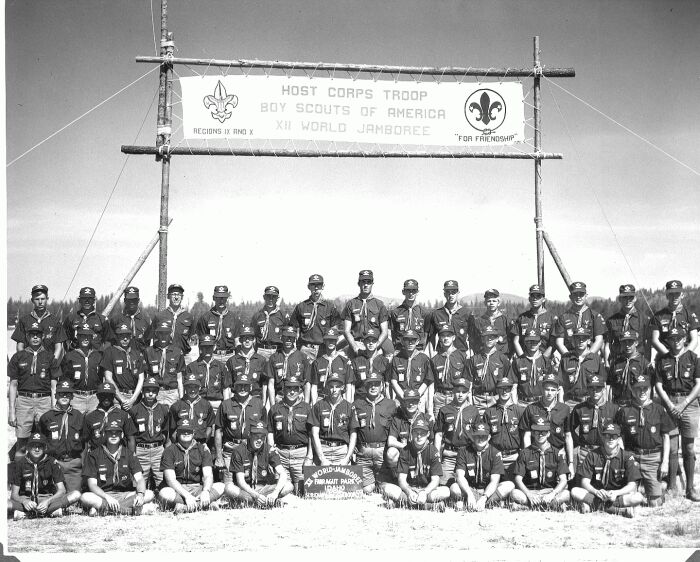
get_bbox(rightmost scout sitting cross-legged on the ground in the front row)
[571,423,644,517]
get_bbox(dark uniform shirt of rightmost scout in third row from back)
[615,402,676,451]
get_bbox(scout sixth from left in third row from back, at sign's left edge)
[268,375,313,490]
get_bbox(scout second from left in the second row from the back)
[61,324,103,414]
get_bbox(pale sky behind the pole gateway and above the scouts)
[5,0,700,303]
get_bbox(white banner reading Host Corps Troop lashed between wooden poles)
[180,75,524,146]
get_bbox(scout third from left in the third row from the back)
[129,377,170,488]
